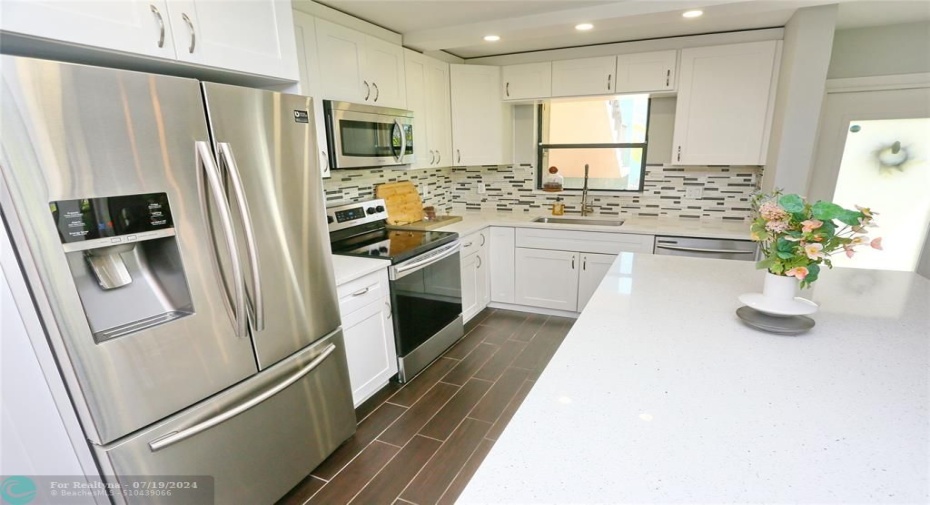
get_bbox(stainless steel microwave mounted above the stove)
[323,100,414,170]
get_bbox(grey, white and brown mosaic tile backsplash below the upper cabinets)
[323,165,762,221]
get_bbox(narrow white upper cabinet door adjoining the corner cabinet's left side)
[426,58,452,167]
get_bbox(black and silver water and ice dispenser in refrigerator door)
[49,193,194,343]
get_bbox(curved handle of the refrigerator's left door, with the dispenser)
[194,140,249,337]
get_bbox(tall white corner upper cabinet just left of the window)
[450,65,513,166]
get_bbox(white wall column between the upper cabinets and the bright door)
[762,5,837,195]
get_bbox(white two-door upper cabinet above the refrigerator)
[0,0,298,81]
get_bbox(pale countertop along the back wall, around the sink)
[438,212,749,240]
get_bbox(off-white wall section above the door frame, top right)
[827,21,930,79]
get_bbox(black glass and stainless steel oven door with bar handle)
[389,241,463,382]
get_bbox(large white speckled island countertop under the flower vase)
[459,253,930,504]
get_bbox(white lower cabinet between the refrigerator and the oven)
[337,269,397,407]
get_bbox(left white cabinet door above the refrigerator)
[0,0,176,60]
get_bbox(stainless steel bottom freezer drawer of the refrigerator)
[96,330,356,504]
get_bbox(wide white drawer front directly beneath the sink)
[516,228,653,254]
